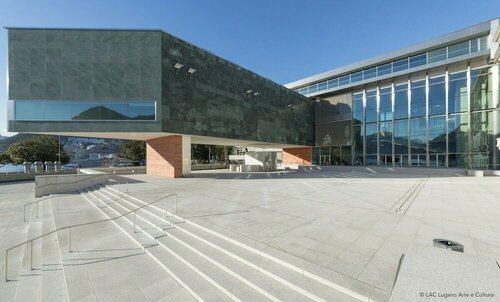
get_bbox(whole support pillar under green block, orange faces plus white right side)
[146,135,191,178]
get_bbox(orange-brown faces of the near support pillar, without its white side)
[146,135,182,178]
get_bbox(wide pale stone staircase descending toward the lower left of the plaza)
[7,185,386,301]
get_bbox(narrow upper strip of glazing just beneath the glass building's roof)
[295,36,488,95]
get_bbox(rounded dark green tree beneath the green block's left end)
[7,135,69,164]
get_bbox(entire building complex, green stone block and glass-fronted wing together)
[4,19,500,177]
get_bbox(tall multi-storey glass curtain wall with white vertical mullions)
[352,66,500,169]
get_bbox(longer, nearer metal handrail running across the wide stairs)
[5,193,177,282]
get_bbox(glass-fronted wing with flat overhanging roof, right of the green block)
[285,19,500,169]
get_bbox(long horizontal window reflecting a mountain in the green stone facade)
[14,101,156,121]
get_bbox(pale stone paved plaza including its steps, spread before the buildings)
[0,167,500,301]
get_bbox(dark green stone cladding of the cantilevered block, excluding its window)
[8,28,314,145]
